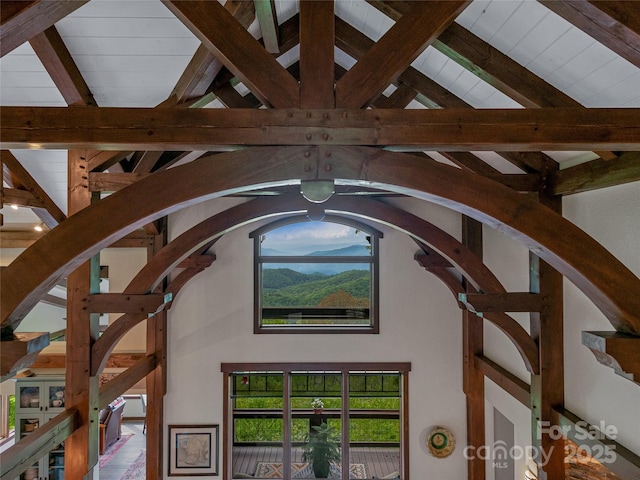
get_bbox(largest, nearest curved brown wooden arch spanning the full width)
[0,146,640,334]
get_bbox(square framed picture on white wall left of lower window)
[169,425,219,477]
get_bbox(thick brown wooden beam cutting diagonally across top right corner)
[539,0,640,68]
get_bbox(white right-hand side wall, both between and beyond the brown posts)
[484,182,640,480]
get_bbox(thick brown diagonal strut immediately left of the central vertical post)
[164,0,299,108]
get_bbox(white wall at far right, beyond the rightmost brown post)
[564,182,640,454]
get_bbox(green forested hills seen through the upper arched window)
[262,268,371,307]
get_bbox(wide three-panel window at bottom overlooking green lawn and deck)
[222,363,411,480]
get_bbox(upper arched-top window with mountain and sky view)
[251,216,382,333]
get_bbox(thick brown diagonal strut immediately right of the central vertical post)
[336,0,469,108]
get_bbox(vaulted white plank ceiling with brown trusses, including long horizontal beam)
[0,0,640,336]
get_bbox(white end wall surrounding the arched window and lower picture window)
[165,200,466,480]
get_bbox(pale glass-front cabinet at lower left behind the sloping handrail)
[15,378,65,480]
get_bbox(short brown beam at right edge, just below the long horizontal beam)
[549,152,640,195]
